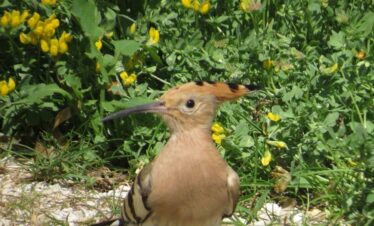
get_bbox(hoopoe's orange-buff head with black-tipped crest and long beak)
[103,81,254,132]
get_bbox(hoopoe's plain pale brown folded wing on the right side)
[224,166,240,217]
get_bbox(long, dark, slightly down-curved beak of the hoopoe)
[101,101,166,122]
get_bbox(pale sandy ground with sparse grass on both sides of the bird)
[0,158,327,226]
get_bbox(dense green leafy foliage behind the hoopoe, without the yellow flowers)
[0,0,374,225]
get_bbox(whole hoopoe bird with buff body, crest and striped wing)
[96,81,258,226]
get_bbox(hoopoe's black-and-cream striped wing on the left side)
[122,164,152,224]
